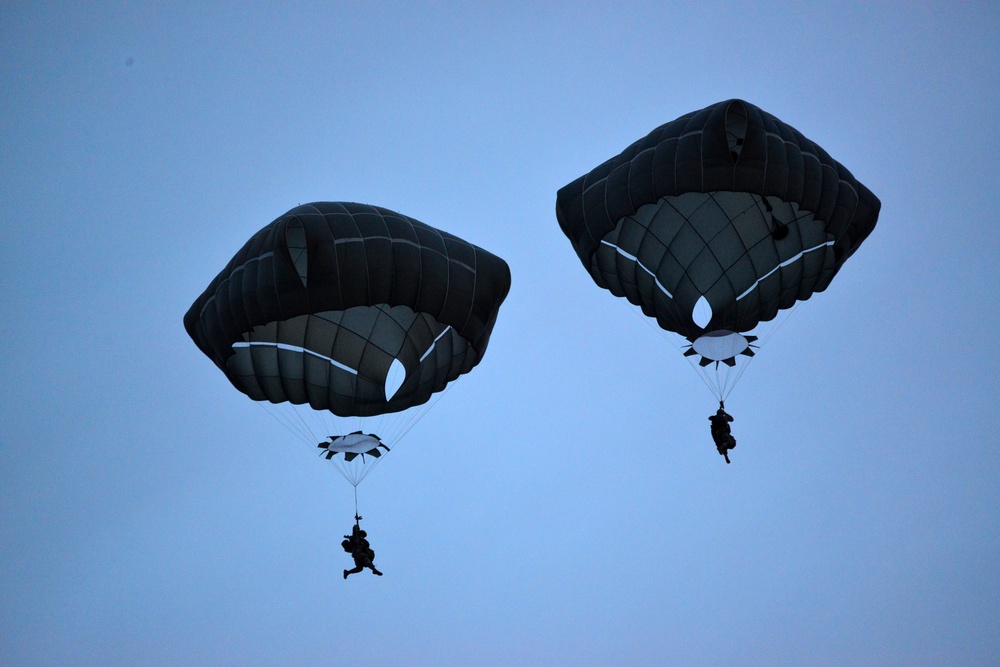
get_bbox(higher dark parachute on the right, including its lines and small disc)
[556,99,881,402]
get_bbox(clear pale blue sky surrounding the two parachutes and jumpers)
[0,2,1000,665]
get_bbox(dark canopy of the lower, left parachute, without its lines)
[184,202,510,417]
